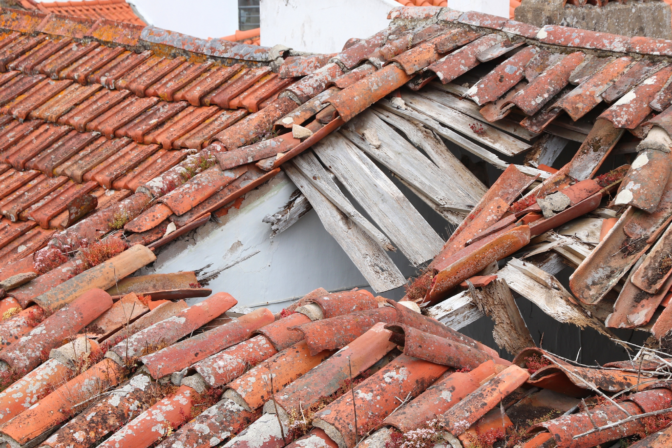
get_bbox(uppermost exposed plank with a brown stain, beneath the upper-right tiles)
[402,92,531,156]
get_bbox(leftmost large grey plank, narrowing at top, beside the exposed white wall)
[283,162,406,293]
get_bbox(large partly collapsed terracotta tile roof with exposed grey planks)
[0,3,672,448]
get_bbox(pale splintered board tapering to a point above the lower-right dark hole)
[497,258,617,339]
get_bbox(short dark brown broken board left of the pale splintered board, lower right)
[469,279,536,356]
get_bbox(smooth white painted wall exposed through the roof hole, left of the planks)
[139,173,388,311]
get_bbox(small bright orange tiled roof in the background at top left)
[21,0,145,26]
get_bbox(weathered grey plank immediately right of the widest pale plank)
[340,111,476,213]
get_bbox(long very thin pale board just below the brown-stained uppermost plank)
[377,99,550,179]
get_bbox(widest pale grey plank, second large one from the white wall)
[313,134,443,266]
